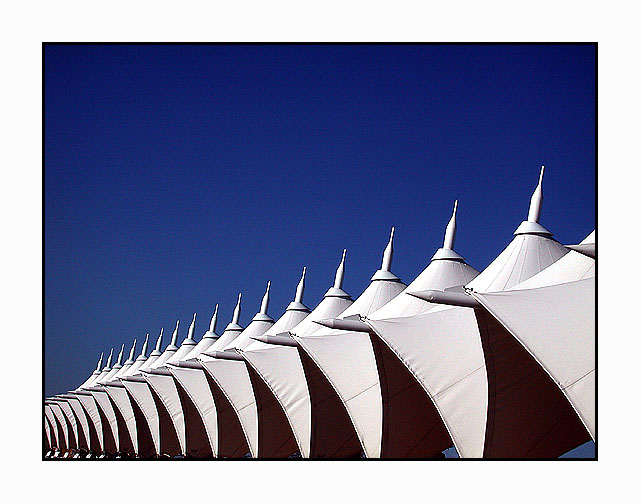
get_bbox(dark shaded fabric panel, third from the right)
[298,347,363,458]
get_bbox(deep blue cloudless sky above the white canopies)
[45,45,595,456]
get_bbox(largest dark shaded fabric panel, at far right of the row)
[474,310,591,458]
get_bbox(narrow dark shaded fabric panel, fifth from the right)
[204,372,249,458]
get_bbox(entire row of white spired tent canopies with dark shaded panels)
[44,169,596,458]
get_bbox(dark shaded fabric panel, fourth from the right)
[247,366,298,458]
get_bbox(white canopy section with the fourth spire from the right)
[241,250,353,458]
